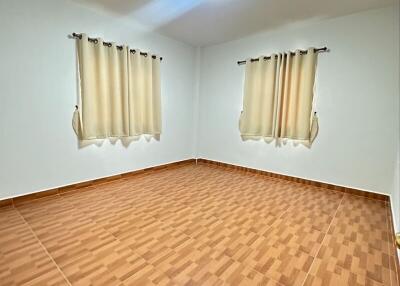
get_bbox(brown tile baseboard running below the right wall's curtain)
[197,159,390,202]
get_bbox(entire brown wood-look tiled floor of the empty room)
[0,165,398,286]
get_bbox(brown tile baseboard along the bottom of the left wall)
[0,159,195,208]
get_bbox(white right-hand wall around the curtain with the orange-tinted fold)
[198,7,398,200]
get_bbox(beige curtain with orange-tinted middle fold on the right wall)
[239,48,318,143]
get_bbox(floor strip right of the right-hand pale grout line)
[306,195,396,285]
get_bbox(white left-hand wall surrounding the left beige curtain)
[0,0,195,199]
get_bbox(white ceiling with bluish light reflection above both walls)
[73,0,393,46]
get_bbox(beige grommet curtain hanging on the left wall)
[73,34,161,140]
